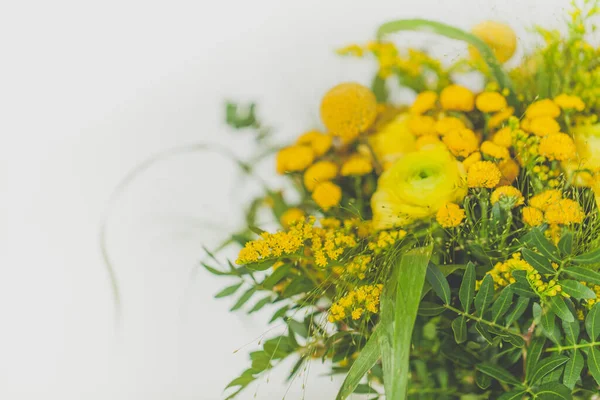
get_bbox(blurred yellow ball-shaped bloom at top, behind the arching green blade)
[469,21,517,63]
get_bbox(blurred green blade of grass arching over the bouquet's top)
[377,19,519,106]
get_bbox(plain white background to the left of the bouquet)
[0,0,568,400]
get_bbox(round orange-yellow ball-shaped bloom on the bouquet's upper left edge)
[321,82,377,142]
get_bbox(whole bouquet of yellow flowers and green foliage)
[203,0,600,400]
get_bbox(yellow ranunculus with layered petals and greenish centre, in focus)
[371,147,467,230]
